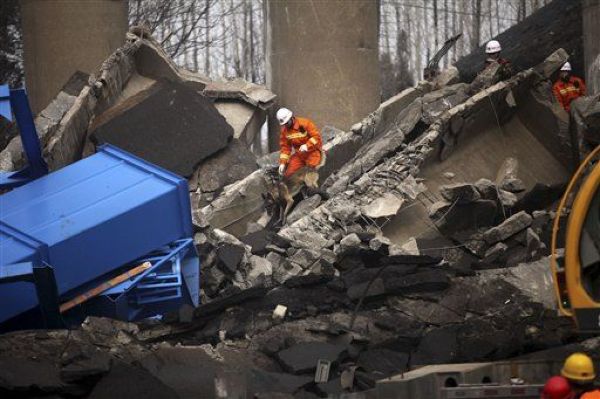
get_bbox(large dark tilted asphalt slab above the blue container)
[90,81,233,177]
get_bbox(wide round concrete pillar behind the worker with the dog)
[266,0,380,136]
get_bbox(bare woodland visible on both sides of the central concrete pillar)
[124,0,536,88]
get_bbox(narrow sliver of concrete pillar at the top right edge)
[583,0,600,94]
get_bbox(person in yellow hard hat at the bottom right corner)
[548,353,600,399]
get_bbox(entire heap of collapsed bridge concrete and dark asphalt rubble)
[0,15,596,398]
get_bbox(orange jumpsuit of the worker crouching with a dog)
[279,117,323,177]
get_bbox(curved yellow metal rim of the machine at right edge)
[550,146,600,322]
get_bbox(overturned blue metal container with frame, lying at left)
[0,145,199,323]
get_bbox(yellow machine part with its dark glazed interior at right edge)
[550,146,600,332]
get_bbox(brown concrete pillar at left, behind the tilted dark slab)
[21,0,128,113]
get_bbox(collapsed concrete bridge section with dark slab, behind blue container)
[0,27,275,209]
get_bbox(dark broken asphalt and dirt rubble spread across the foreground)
[0,255,573,398]
